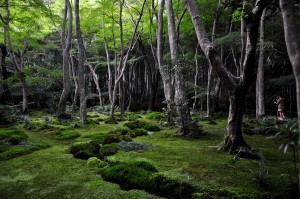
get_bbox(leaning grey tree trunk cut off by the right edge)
[280,0,300,130]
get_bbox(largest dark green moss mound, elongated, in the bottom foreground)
[101,161,196,198]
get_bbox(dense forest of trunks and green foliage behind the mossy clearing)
[0,0,299,151]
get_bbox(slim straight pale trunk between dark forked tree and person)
[256,9,266,119]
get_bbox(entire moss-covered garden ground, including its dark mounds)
[0,112,299,199]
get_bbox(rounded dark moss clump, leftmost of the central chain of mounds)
[70,142,98,160]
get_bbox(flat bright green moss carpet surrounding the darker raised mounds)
[0,112,299,199]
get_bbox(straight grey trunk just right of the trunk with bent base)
[74,0,87,124]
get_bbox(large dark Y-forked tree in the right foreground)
[183,0,267,153]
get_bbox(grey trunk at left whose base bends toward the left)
[57,0,73,115]
